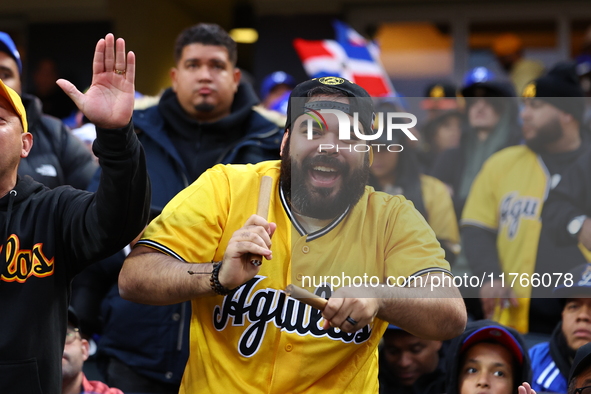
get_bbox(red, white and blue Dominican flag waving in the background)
[293,21,395,97]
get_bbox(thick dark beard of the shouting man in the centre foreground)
[281,141,369,220]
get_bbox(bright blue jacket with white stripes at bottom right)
[529,342,568,393]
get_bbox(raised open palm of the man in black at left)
[57,33,135,129]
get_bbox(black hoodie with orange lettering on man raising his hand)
[0,126,150,394]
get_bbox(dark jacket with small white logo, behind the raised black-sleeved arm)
[18,94,98,190]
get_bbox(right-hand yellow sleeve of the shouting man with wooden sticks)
[385,197,450,278]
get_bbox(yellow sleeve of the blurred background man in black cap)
[460,156,499,232]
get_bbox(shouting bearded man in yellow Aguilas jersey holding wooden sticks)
[119,77,466,393]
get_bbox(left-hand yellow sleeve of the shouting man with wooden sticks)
[138,168,230,263]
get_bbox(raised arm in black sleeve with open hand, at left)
[56,34,151,264]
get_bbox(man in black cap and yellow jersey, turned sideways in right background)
[460,63,591,335]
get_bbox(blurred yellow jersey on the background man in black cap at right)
[460,145,589,333]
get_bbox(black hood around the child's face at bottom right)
[445,320,531,394]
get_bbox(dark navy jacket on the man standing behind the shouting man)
[85,84,283,384]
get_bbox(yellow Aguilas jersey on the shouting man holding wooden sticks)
[139,161,449,393]
